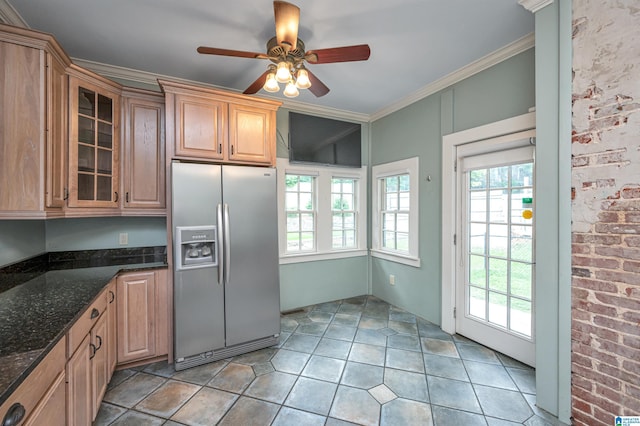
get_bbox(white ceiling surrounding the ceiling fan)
[0,0,534,115]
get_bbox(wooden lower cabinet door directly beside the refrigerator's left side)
[116,269,169,364]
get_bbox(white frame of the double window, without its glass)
[276,158,368,264]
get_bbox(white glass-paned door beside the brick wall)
[456,148,535,364]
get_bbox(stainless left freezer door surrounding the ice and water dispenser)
[171,162,225,360]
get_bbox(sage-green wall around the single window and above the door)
[370,49,535,324]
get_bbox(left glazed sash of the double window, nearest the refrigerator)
[285,174,316,252]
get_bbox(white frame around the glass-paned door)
[441,112,536,334]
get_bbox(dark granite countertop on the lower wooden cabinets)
[0,262,167,404]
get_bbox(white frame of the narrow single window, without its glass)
[371,157,420,267]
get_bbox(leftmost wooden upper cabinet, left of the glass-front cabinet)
[0,24,70,219]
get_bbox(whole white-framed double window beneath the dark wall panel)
[277,158,367,263]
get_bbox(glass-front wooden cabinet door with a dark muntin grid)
[69,76,120,208]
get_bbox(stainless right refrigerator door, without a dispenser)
[222,166,280,346]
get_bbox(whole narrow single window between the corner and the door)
[371,157,420,266]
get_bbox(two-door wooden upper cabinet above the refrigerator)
[158,80,280,165]
